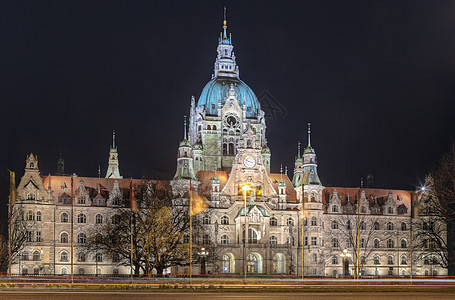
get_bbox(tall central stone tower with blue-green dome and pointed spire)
[189,11,271,172]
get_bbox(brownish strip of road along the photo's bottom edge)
[0,291,454,300]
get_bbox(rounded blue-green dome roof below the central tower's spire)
[197,77,261,118]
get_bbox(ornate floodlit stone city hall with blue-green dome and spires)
[8,14,447,276]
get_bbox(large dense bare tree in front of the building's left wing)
[87,182,189,276]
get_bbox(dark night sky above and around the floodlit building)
[0,0,455,217]
